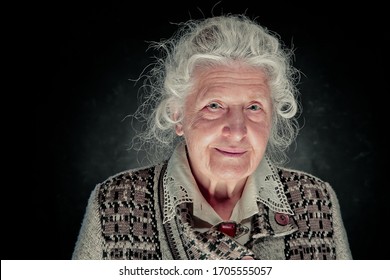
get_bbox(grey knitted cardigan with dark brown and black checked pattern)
[72,163,352,260]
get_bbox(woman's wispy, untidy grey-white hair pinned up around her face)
[132,15,300,164]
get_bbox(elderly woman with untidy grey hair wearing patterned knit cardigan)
[72,15,352,260]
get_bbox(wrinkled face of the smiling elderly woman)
[176,65,272,185]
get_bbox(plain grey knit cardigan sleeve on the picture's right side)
[326,183,352,260]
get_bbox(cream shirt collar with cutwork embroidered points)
[163,142,293,224]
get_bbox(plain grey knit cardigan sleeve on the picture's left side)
[72,185,104,260]
